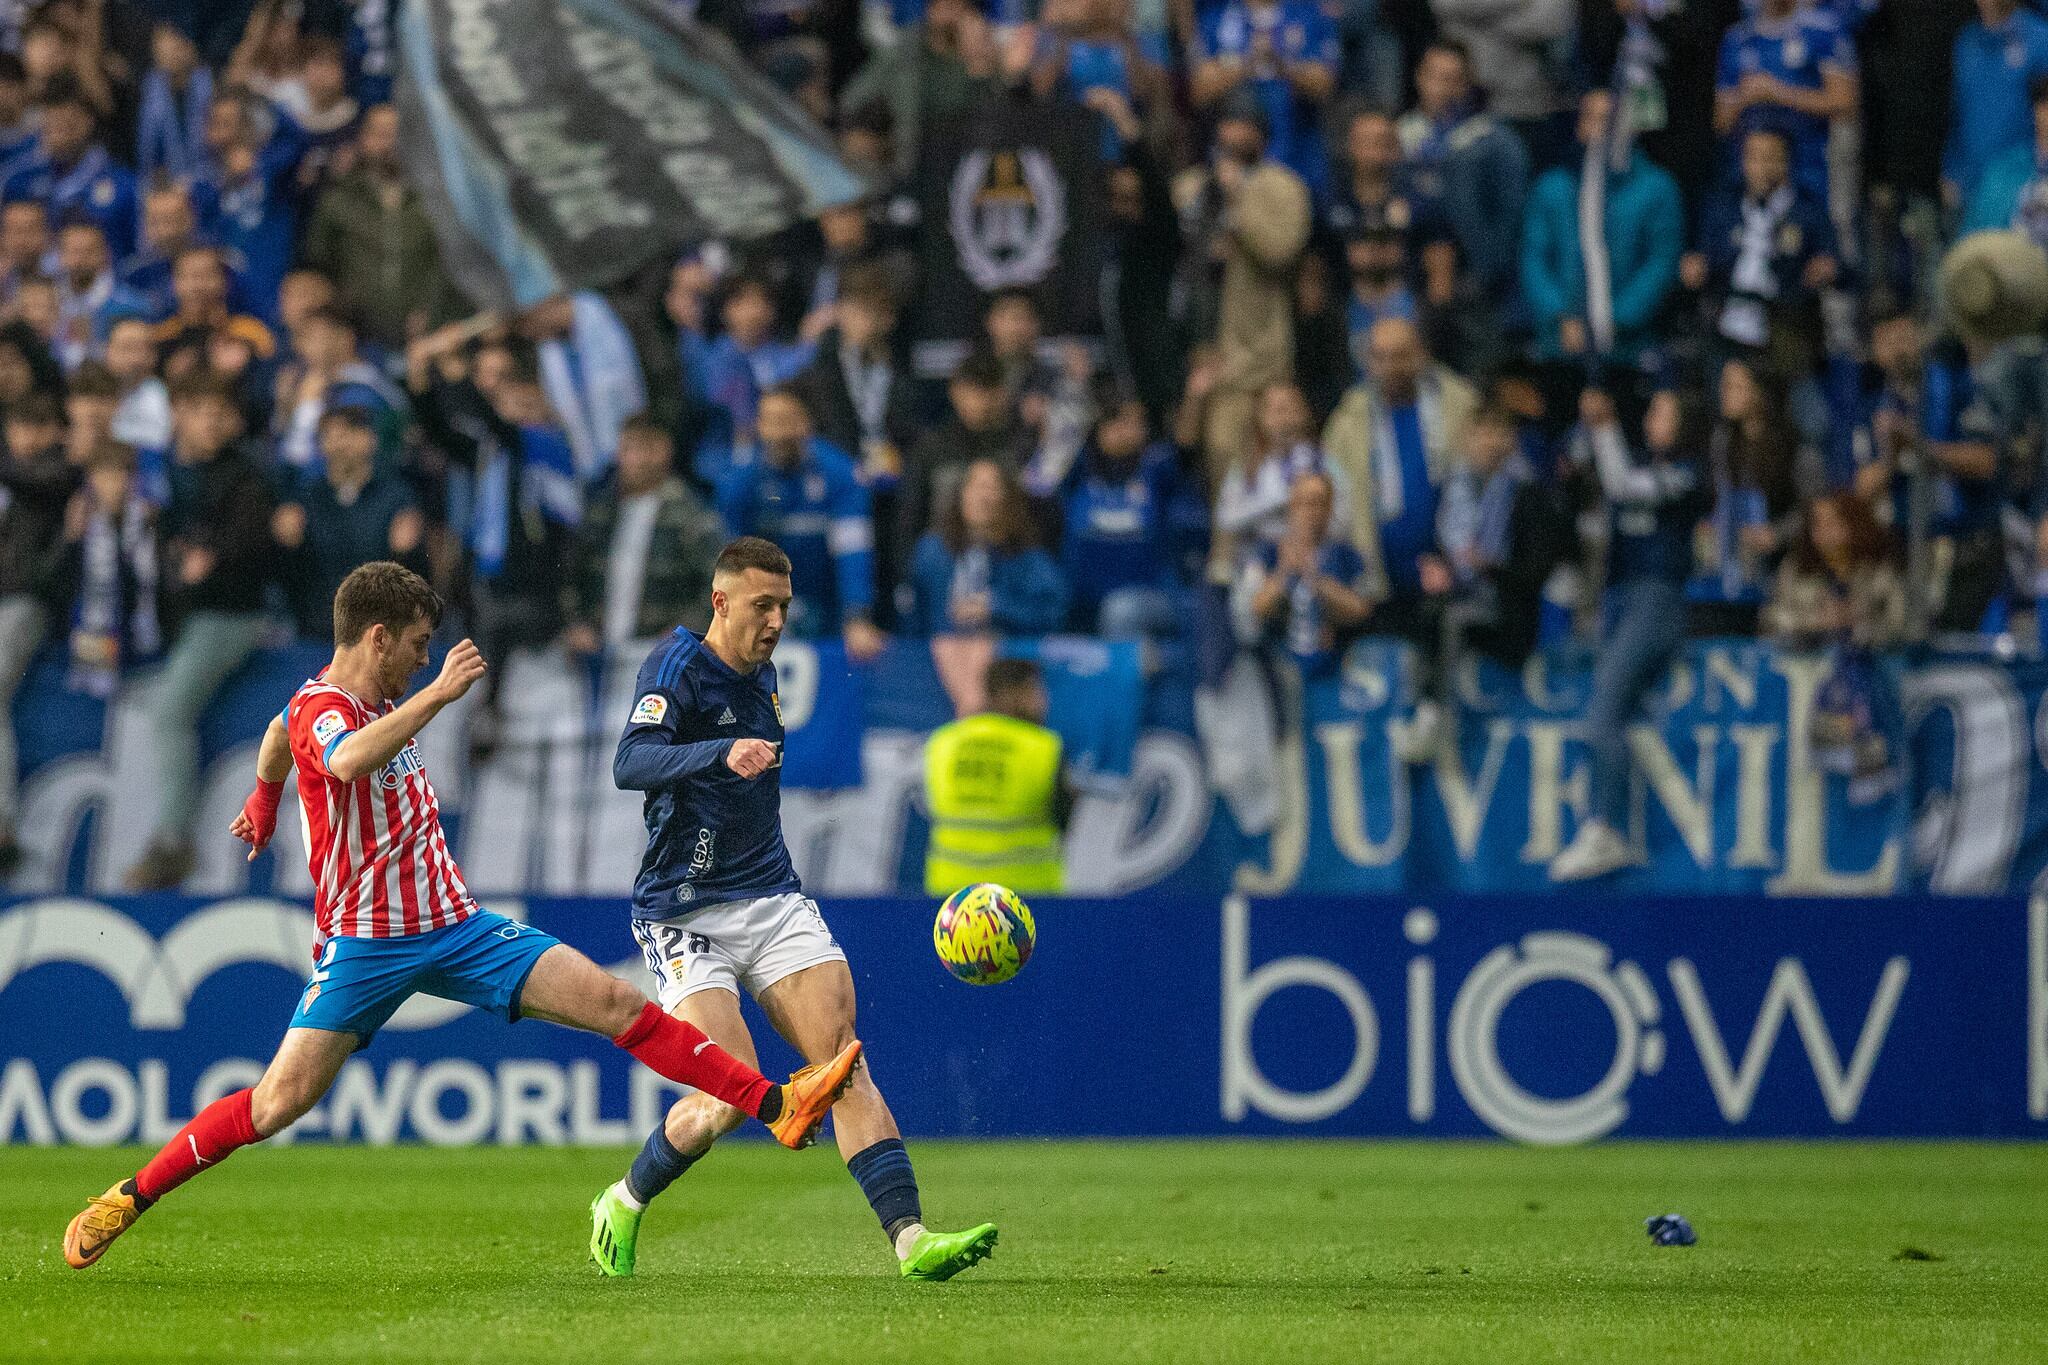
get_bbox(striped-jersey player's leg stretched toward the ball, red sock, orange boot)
[518,943,860,1148]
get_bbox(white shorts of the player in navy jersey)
[633,890,846,1011]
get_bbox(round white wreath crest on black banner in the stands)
[948,147,1067,291]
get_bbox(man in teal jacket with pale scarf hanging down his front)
[1522,90,1686,360]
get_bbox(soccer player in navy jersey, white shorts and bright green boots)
[590,536,995,1279]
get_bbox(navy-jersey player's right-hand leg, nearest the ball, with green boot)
[760,960,995,1281]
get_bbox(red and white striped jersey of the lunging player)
[285,677,477,941]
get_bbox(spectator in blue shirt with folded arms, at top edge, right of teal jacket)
[1714,0,1860,203]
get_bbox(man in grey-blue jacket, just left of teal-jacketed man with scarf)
[1397,39,1530,307]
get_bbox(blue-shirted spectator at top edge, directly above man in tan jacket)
[1194,0,1341,190]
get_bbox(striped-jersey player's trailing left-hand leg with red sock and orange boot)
[63,1029,356,1271]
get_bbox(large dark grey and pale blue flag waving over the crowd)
[397,0,864,309]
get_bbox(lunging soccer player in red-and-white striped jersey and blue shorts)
[63,563,860,1269]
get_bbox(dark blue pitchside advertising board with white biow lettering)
[0,896,2048,1144]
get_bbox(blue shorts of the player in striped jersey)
[291,911,561,1048]
